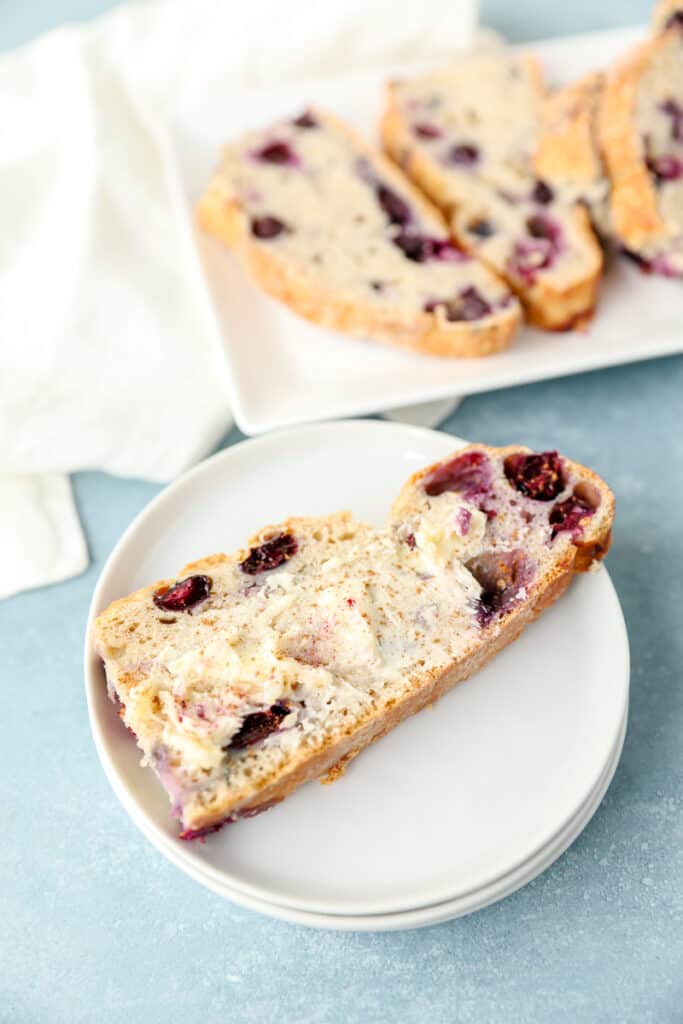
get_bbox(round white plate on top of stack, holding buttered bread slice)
[86,421,629,916]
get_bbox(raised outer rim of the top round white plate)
[84,420,630,916]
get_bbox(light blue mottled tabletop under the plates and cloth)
[0,0,683,1024]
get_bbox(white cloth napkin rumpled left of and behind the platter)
[0,0,476,596]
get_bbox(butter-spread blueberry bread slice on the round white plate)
[94,445,613,839]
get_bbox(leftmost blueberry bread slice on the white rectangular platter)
[199,110,520,356]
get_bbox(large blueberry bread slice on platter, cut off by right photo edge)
[598,19,683,276]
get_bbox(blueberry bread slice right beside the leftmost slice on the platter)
[381,54,602,330]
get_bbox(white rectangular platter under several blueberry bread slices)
[173,29,683,434]
